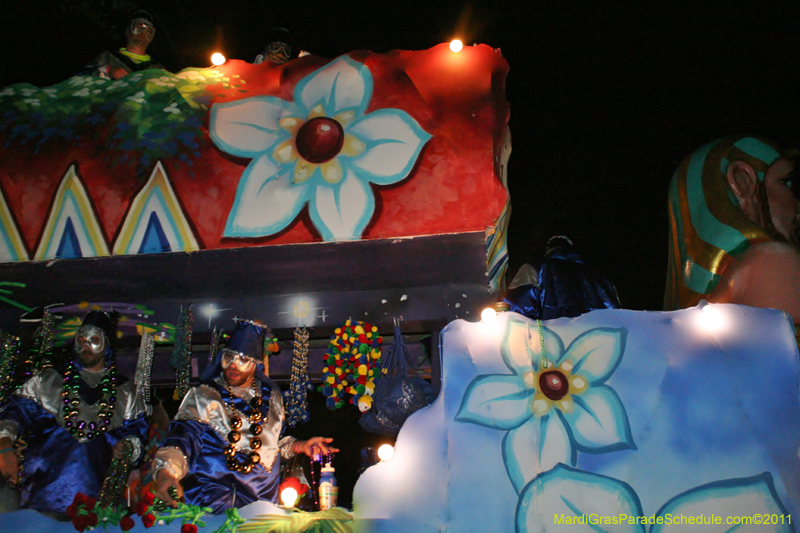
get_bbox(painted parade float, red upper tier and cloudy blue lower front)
[0,39,800,533]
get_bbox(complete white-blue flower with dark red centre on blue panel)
[456,316,636,492]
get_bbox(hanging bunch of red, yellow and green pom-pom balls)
[319,320,383,410]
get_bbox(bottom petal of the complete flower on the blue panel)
[503,414,576,492]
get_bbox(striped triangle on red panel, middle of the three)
[33,165,109,261]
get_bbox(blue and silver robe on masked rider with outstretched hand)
[154,377,296,513]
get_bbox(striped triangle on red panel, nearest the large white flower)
[114,161,200,255]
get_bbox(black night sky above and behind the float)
[0,0,800,310]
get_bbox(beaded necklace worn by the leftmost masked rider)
[61,361,117,440]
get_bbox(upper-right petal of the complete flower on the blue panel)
[557,328,628,384]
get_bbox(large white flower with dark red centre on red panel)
[209,56,431,241]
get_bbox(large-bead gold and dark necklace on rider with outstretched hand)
[220,379,264,474]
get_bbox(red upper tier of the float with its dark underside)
[0,41,510,331]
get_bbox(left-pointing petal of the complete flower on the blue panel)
[455,375,534,430]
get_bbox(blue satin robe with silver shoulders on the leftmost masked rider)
[0,369,147,513]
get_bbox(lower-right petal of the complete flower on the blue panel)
[563,385,636,453]
